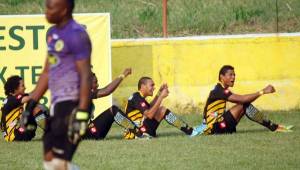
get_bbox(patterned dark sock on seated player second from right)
[164,109,193,135]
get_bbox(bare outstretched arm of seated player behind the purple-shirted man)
[96,68,132,98]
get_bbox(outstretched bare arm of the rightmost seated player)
[228,85,275,104]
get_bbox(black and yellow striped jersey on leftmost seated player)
[1,95,24,141]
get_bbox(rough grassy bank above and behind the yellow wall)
[0,0,300,38]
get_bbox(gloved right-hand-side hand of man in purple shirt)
[68,109,89,144]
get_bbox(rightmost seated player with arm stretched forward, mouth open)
[199,65,292,134]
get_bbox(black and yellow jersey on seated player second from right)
[125,92,150,126]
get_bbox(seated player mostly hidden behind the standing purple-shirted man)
[83,68,145,139]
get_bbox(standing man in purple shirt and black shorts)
[22,0,91,170]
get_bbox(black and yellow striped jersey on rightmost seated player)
[203,83,232,134]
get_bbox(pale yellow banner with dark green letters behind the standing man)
[0,14,112,116]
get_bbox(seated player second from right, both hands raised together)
[124,77,201,139]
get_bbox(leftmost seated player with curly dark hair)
[1,76,48,141]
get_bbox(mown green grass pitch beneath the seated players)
[0,110,300,170]
